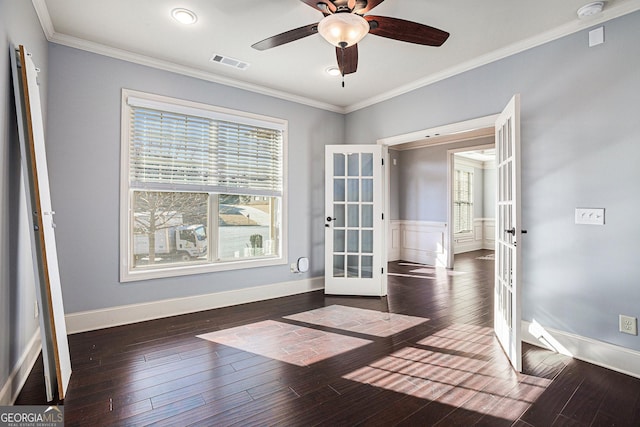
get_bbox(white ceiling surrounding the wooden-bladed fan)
[32,0,640,113]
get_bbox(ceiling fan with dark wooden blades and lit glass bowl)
[251,0,449,86]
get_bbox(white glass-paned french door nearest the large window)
[325,145,387,296]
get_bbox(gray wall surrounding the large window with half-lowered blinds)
[47,44,344,313]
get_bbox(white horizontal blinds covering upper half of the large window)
[129,102,283,196]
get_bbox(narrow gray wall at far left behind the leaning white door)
[0,0,48,403]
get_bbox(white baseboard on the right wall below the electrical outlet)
[522,320,640,378]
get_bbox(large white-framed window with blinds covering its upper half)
[120,90,287,281]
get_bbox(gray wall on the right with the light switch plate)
[345,12,640,350]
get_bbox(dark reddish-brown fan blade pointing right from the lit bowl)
[364,15,449,46]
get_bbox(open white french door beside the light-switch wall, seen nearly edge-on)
[494,95,523,372]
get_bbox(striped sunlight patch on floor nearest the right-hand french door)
[343,325,551,419]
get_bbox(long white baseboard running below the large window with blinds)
[65,277,324,334]
